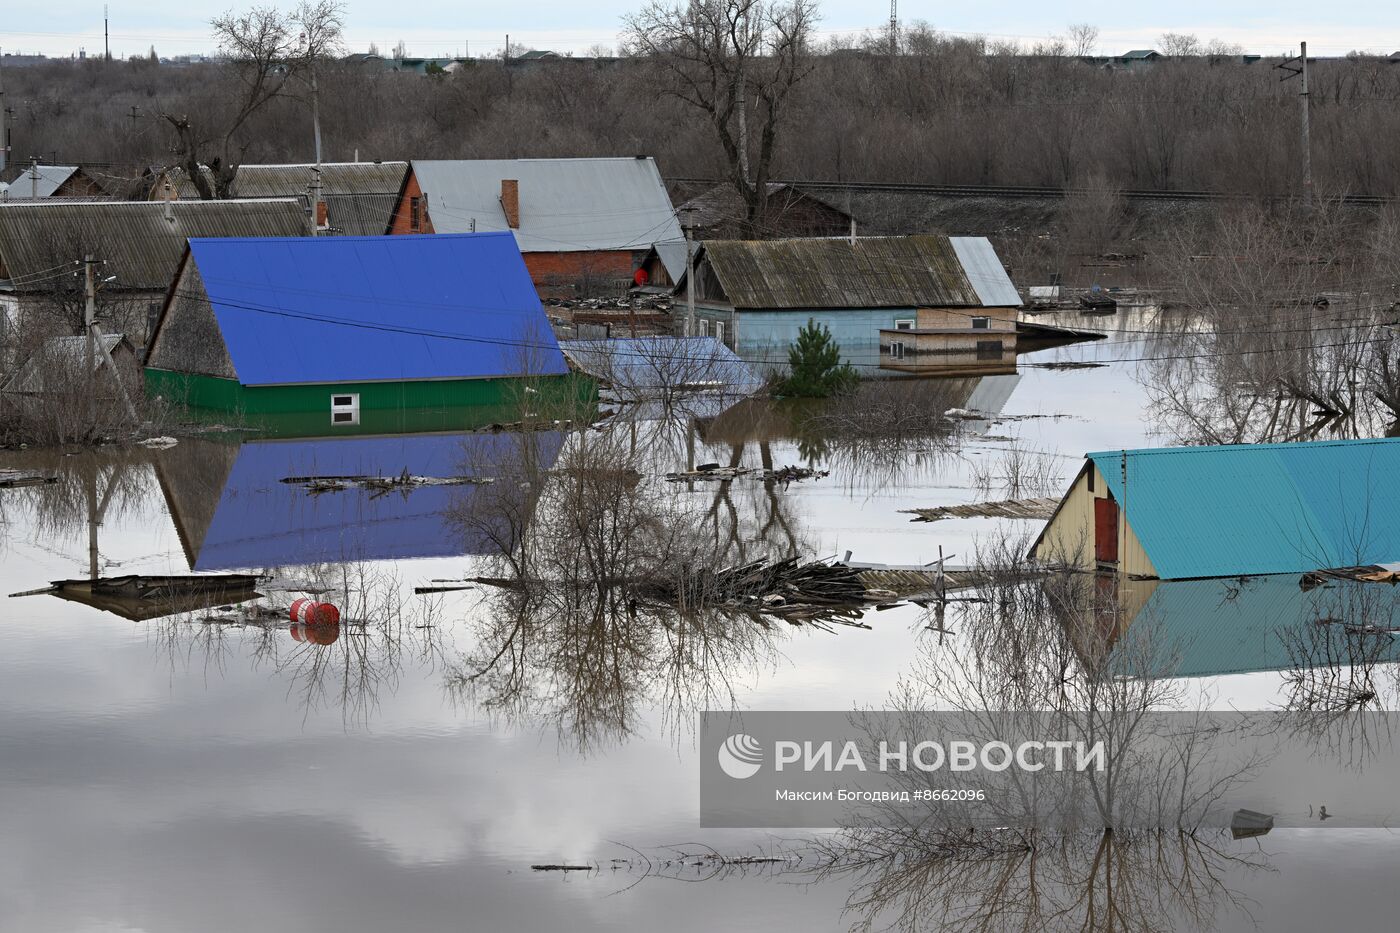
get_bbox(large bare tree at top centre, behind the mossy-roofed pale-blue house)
[624,0,818,228]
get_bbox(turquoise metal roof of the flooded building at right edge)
[1088,438,1400,580]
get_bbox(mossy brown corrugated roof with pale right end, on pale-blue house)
[703,235,1021,308]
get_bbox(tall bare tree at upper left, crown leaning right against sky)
[161,0,344,200]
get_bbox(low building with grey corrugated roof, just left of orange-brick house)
[147,163,409,237]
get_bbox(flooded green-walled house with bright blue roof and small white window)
[146,234,568,427]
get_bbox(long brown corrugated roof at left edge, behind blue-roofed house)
[0,199,307,291]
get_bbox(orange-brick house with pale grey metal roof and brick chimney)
[389,157,685,293]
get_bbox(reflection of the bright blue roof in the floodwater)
[190,431,564,570]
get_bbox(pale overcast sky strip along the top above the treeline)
[0,0,1400,56]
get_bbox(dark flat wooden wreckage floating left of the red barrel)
[10,573,262,622]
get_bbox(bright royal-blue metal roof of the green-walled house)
[189,233,567,385]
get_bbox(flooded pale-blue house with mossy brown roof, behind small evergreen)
[675,235,1021,373]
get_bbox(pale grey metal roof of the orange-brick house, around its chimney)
[413,158,685,264]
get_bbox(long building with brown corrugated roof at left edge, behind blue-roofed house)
[0,199,307,353]
